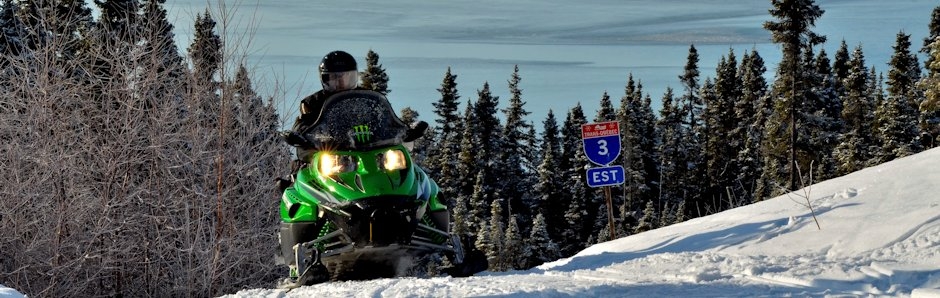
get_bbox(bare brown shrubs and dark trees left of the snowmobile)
[0,0,290,297]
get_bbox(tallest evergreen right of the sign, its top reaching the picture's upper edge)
[763,0,825,193]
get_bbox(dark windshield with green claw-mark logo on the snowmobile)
[302,90,408,150]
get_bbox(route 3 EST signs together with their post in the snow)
[581,121,626,239]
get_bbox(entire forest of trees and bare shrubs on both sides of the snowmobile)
[0,0,940,296]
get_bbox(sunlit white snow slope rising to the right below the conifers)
[184,148,940,298]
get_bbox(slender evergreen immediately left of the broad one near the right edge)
[834,46,873,175]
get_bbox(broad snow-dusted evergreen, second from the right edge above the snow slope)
[875,32,923,163]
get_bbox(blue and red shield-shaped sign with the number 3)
[581,121,620,166]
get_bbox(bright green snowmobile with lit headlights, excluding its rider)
[279,90,488,288]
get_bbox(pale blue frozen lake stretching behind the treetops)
[166,0,938,128]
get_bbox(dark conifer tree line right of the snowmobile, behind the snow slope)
[406,0,940,270]
